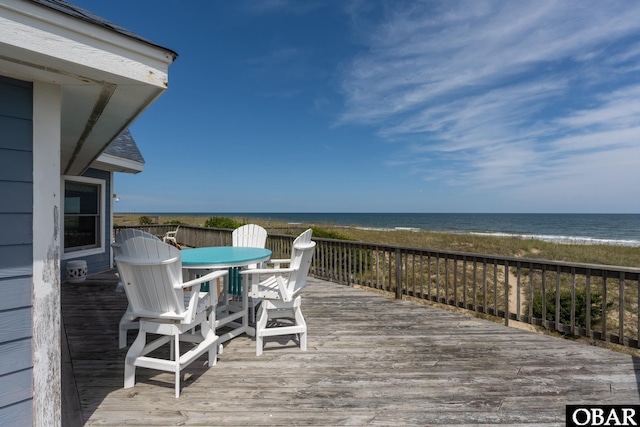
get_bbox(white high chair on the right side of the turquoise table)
[241,229,316,356]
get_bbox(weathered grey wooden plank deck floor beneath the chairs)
[62,272,640,427]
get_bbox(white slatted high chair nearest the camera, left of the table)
[116,237,227,397]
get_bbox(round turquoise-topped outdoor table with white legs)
[180,246,271,343]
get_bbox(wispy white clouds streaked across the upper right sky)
[339,1,640,206]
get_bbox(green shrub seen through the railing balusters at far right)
[533,289,602,328]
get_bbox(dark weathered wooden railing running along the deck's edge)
[115,225,640,348]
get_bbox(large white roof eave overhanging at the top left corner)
[0,0,176,175]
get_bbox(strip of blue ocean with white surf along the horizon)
[151,212,640,247]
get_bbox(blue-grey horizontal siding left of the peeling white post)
[0,76,33,425]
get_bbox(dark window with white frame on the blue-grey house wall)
[64,177,104,255]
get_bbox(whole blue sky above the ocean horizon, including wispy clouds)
[72,0,640,213]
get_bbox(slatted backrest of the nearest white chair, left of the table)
[116,236,187,319]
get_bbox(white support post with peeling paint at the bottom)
[32,82,62,427]
